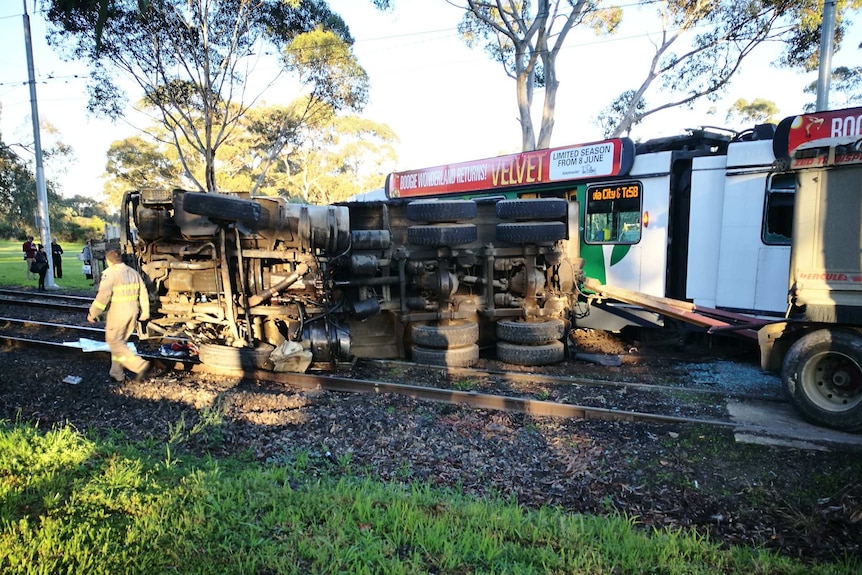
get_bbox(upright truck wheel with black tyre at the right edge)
[781,329,862,431]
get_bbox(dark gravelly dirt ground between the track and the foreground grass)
[0,324,862,561]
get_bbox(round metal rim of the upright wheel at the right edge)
[802,351,862,412]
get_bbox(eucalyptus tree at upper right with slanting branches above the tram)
[598,0,862,137]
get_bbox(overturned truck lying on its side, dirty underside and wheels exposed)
[122,190,580,370]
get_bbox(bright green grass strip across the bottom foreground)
[0,422,862,575]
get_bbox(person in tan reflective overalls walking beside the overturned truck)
[87,250,150,381]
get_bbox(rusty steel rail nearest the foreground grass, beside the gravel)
[0,335,739,429]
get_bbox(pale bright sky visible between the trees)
[0,0,862,201]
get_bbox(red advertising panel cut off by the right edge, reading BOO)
[772,108,862,158]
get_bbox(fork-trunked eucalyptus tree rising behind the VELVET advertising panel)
[458,0,622,151]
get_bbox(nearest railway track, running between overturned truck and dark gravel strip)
[0,306,788,428]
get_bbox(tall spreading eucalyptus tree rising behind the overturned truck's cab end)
[47,0,368,191]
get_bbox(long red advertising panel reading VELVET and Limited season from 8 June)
[386,138,635,198]
